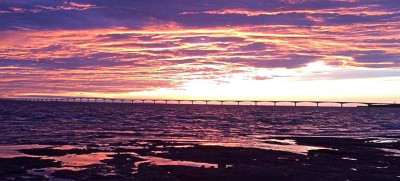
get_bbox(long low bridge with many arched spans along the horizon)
[0,97,390,107]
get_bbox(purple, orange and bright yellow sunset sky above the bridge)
[0,0,400,102]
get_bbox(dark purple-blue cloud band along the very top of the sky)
[0,0,399,29]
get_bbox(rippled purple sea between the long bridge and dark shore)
[0,102,400,146]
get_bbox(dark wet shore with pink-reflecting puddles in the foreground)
[0,137,400,181]
